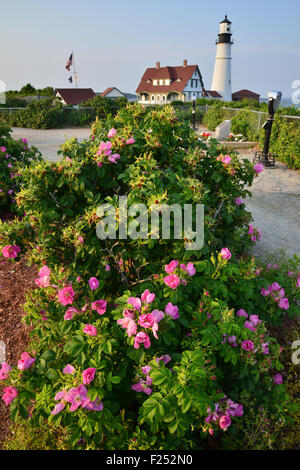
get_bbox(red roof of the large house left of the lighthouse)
[136,65,202,93]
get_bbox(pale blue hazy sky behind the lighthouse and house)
[0,0,300,97]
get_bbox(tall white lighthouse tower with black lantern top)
[211,15,233,101]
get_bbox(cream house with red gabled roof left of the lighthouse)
[136,60,204,104]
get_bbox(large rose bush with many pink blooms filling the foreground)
[0,105,300,449]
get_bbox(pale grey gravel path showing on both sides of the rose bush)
[12,127,300,256]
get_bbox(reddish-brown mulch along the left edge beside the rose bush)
[0,257,37,449]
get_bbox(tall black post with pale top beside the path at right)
[255,91,282,167]
